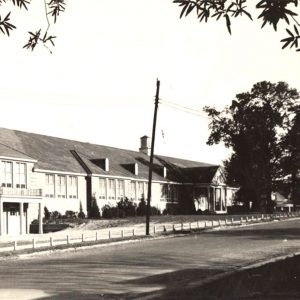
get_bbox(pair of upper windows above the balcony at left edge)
[0,161,27,189]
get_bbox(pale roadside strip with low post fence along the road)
[0,213,299,253]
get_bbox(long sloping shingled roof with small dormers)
[0,128,219,183]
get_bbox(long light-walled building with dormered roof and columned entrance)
[0,128,235,235]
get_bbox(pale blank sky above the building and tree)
[0,0,300,164]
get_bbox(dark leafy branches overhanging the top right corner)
[173,0,300,51]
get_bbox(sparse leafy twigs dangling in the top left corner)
[0,0,66,52]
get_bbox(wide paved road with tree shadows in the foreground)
[0,220,300,299]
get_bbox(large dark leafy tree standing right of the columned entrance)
[204,81,299,211]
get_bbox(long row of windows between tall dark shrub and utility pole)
[99,178,148,201]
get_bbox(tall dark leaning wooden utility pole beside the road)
[146,79,160,235]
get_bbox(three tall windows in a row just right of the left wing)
[44,174,78,199]
